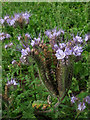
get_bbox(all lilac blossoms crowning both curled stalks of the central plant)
[18,28,89,64]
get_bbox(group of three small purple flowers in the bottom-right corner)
[71,96,90,111]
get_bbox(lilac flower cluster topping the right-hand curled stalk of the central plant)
[45,29,88,60]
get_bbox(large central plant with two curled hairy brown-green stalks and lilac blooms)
[18,28,88,100]
